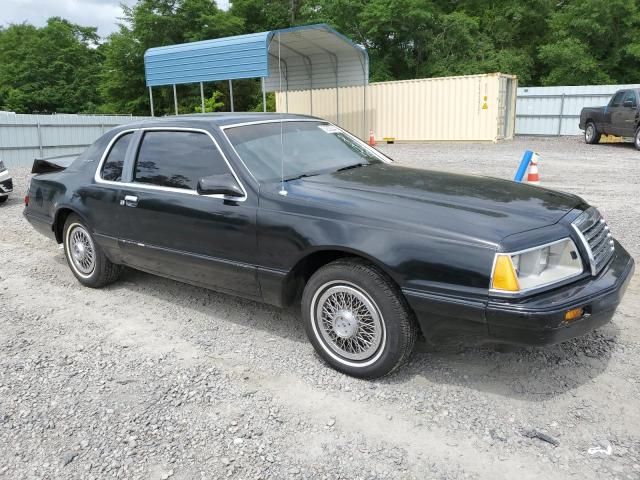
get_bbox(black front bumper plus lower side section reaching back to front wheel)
[403,242,634,345]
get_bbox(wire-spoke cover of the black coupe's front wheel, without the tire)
[311,281,386,366]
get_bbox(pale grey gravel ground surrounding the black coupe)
[0,138,640,479]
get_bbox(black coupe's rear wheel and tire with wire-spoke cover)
[63,214,122,288]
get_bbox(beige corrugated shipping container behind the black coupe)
[276,73,517,142]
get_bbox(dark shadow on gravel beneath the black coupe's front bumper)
[388,319,619,402]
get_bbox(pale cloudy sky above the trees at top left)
[0,0,229,37]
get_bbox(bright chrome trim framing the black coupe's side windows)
[93,126,248,202]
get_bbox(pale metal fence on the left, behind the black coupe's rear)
[0,112,151,167]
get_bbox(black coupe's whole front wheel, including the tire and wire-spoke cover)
[302,259,418,378]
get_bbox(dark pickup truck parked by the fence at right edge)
[580,88,640,150]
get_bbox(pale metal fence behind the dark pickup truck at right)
[516,84,640,135]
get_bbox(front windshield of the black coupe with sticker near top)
[225,121,382,182]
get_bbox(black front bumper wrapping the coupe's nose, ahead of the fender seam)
[486,242,634,345]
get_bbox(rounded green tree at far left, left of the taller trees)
[0,17,101,113]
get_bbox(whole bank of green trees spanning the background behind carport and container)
[6,0,640,115]
